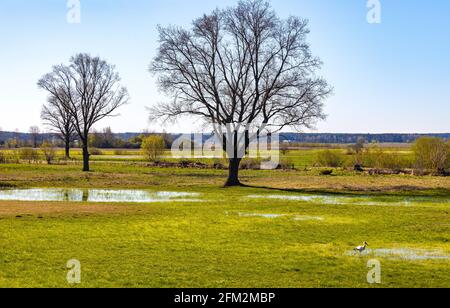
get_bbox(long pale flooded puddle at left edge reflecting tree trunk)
[0,188,201,203]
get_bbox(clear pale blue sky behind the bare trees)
[0,0,450,133]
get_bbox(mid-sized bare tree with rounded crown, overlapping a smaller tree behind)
[38,54,128,171]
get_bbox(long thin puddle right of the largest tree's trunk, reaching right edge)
[247,195,450,206]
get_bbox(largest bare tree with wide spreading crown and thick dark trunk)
[150,0,331,186]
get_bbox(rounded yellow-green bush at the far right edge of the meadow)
[413,137,450,174]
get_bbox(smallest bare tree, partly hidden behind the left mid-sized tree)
[41,93,76,159]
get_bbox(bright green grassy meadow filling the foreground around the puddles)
[0,153,450,287]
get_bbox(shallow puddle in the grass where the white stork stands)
[347,248,450,261]
